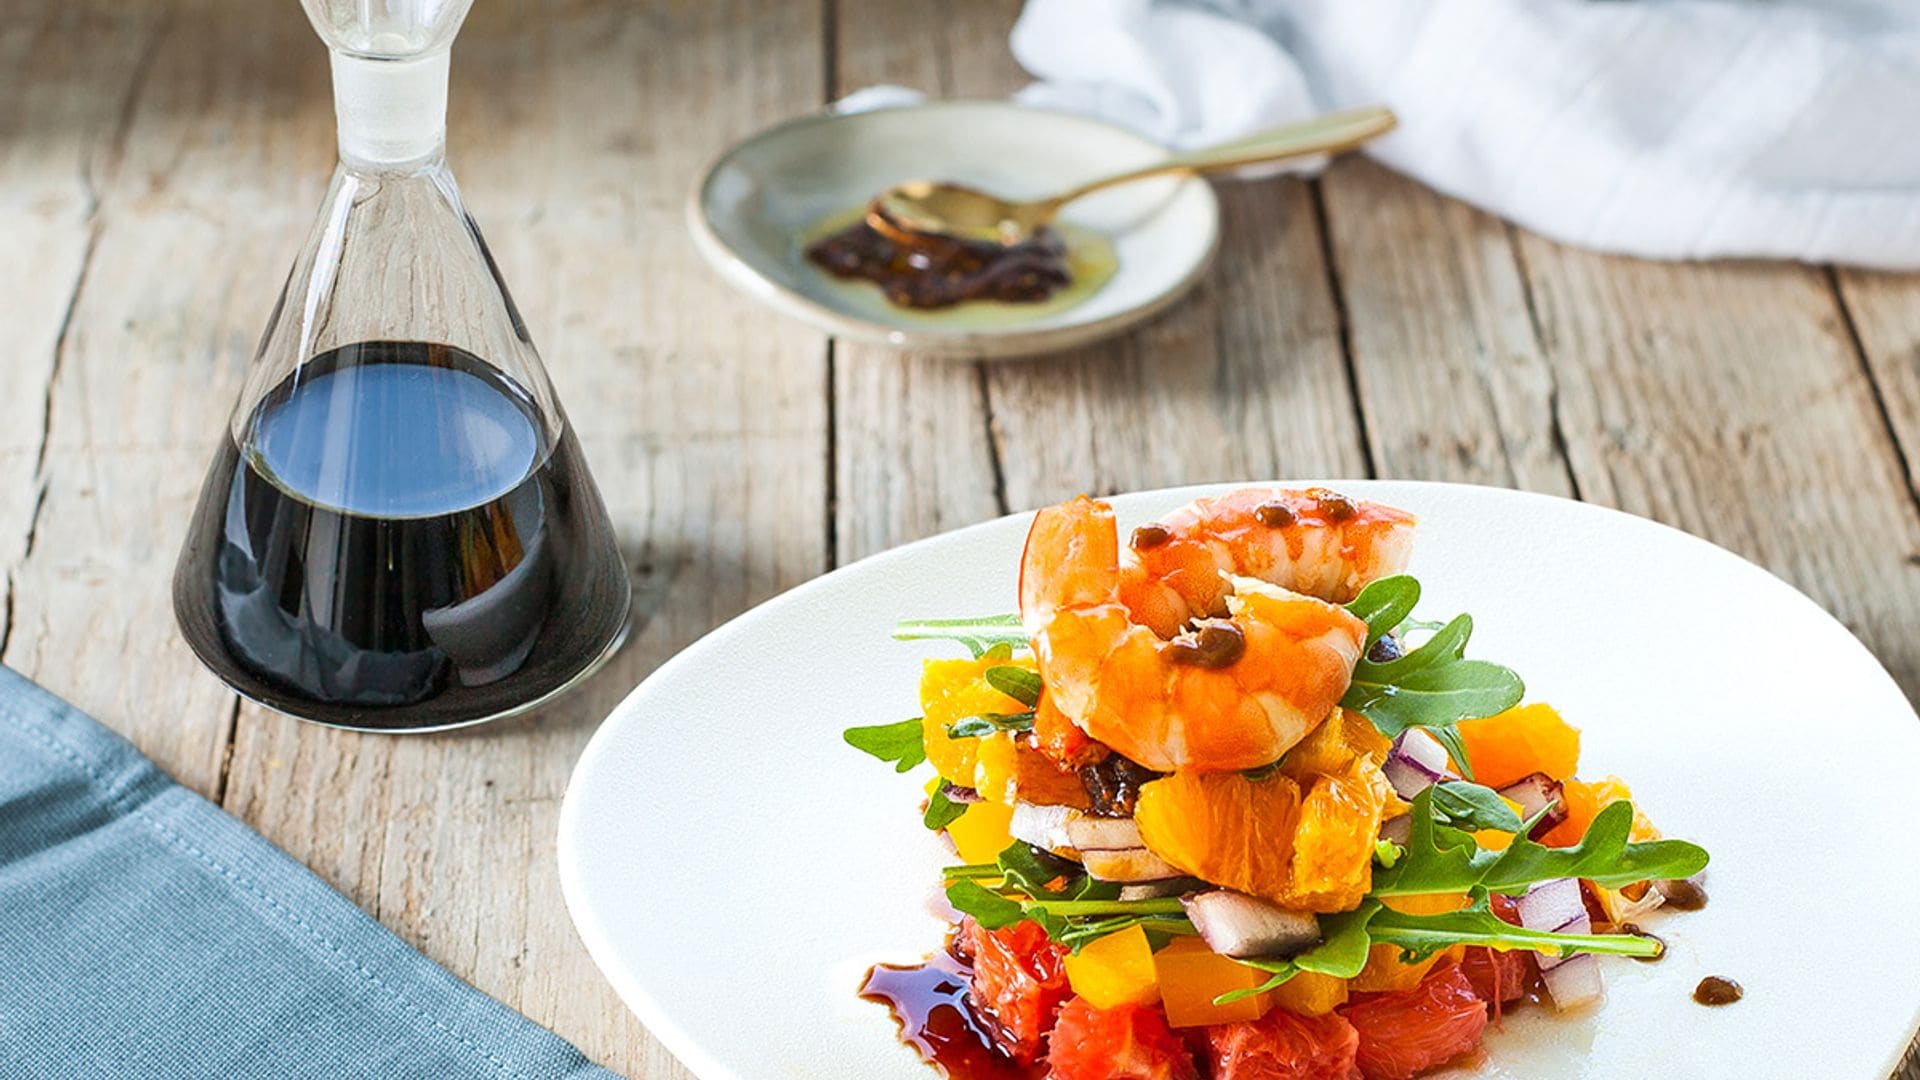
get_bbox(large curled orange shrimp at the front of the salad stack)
[1020,496,1367,773]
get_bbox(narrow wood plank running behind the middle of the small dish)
[833,0,1025,563]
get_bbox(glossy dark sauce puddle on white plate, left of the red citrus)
[860,951,1044,1080]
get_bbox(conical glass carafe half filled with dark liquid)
[173,0,628,730]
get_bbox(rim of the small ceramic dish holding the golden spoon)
[684,98,1219,359]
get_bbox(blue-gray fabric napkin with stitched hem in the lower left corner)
[0,667,612,1080]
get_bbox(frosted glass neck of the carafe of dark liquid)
[332,48,449,171]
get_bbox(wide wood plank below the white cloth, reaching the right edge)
[1521,236,1920,694]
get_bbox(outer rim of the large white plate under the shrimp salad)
[555,477,1920,1080]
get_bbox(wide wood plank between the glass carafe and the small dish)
[227,0,828,1078]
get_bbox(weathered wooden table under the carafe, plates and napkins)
[0,0,1920,1078]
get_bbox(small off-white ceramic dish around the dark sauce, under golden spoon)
[687,102,1219,356]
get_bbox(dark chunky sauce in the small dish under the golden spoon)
[806,206,1073,309]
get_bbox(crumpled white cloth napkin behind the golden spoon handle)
[1012,0,1920,267]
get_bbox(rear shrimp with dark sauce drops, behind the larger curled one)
[1119,488,1415,638]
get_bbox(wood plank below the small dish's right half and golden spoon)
[989,179,1367,509]
